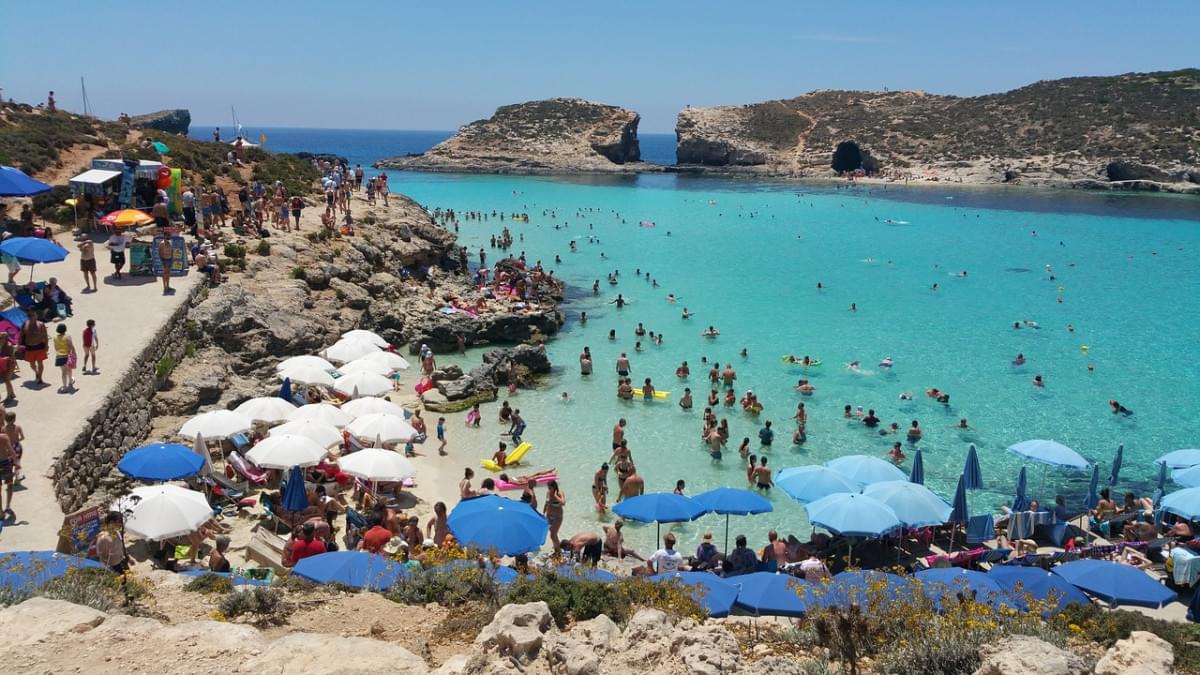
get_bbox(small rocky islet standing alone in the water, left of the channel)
[376,98,641,173]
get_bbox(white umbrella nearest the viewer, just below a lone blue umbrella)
[113,484,212,542]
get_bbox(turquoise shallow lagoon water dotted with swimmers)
[392,173,1200,550]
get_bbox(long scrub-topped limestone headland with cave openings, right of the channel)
[676,70,1200,187]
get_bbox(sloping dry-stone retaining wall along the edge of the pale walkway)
[50,283,208,513]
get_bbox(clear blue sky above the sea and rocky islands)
[0,0,1200,132]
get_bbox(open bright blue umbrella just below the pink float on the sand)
[446,495,550,555]
